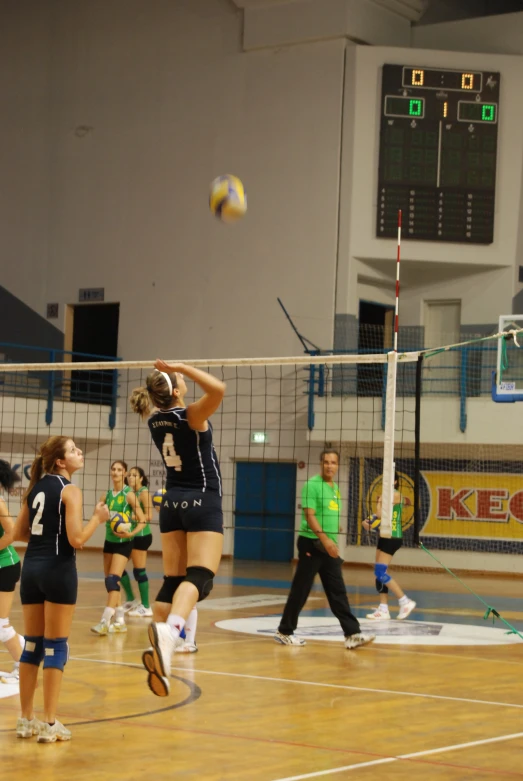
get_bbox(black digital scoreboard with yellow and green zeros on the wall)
[376,65,500,244]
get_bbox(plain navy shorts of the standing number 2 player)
[20,556,78,605]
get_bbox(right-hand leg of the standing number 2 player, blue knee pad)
[37,600,76,743]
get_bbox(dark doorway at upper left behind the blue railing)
[70,304,120,404]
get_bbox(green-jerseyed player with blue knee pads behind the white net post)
[362,475,416,621]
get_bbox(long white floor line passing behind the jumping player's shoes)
[70,656,523,708]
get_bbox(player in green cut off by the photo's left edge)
[0,460,24,683]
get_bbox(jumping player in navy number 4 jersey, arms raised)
[130,361,225,697]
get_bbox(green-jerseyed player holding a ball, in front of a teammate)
[91,461,146,635]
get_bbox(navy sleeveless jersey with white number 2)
[25,475,75,559]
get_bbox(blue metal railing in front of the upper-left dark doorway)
[0,342,121,429]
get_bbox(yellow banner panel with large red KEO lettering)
[421,471,523,540]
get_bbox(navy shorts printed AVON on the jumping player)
[160,488,223,534]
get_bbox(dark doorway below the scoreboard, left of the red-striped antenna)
[358,301,394,396]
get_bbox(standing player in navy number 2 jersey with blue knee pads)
[15,436,109,743]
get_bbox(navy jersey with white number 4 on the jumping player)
[148,407,222,496]
